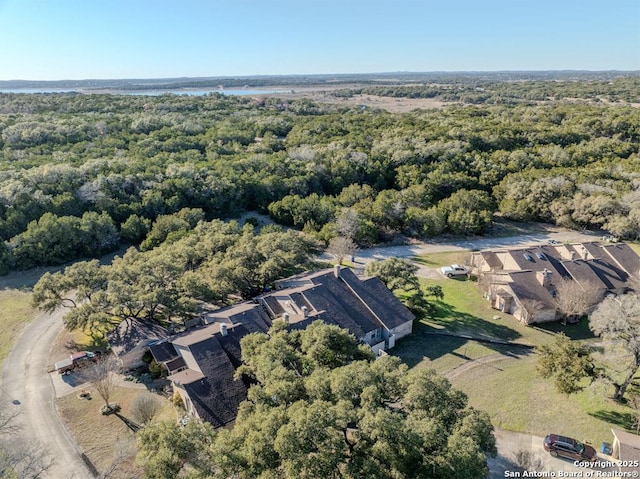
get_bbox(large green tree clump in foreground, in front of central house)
[138,322,496,479]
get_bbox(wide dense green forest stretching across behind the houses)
[0,78,640,273]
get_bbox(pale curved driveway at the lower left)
[0,310,93,479]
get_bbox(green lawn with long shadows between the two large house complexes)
[393,274,631,446]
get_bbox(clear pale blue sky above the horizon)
[0,0,640,80]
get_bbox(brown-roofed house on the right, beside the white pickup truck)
[472,242,640,324]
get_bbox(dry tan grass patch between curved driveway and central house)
[57,387,176,478]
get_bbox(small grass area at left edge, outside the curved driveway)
[0,289,34,366]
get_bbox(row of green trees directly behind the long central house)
[33,221,316,334]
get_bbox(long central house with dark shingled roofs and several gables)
[149,266,415,427]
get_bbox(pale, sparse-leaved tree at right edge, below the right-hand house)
[589,293,640,401]
